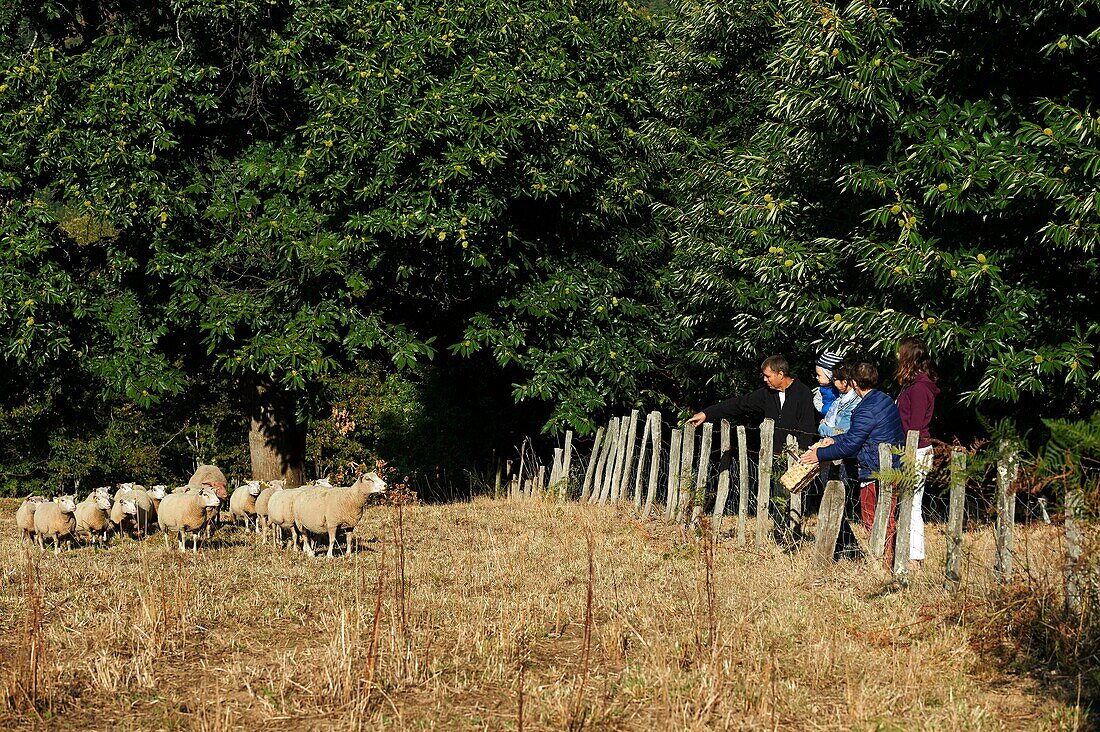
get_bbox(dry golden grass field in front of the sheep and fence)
[0,500,1088,730]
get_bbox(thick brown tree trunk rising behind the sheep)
[249,381,306,488]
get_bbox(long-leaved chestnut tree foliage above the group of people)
[660,0,1100,422]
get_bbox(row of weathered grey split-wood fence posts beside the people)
[497,411,1080,594]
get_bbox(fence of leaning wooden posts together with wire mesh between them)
[496,412,1086,598]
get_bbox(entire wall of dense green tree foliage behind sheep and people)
[0,0,1100,490]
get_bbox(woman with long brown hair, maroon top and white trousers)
[894,337,939,569]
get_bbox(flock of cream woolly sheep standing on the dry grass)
[15,466,386,557]
